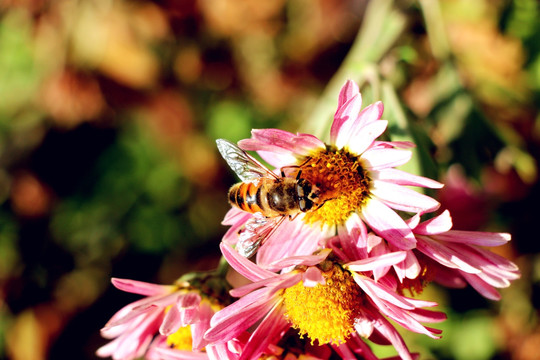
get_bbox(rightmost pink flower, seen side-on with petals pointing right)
[350,210,520,300]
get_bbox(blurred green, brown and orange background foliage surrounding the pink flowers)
[0,0,540,360]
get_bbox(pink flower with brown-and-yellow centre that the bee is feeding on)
[220,81,442,265]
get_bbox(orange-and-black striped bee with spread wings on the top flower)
[216,139,322,257]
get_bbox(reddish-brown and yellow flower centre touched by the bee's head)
[295,147,371,225]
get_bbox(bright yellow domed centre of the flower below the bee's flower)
[282,265,362,345]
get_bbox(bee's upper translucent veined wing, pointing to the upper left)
[216,139,278,182]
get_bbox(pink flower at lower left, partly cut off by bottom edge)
[97,278,228,359]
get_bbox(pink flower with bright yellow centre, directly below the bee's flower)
[205,243,445,359]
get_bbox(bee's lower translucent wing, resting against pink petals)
[236,213,285,258]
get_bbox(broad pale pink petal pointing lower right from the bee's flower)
[361,199,416,250]
